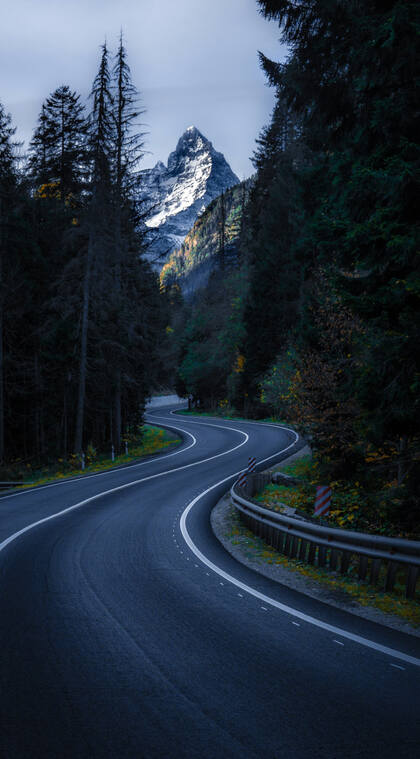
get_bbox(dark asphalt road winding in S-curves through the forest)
[0,409,420,759]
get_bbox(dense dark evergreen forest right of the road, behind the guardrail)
[170,0,420,534]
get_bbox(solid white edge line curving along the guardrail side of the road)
[179,422,420,667]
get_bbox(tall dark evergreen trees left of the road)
[0,36,171,475]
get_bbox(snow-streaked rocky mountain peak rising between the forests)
[142,126,239,268]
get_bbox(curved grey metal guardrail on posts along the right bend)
[231,473,420,598]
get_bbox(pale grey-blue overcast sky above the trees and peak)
[0,0,285,179]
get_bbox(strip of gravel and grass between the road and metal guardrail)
[226,498,420,628]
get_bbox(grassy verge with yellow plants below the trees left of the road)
[7,424,181,487]
